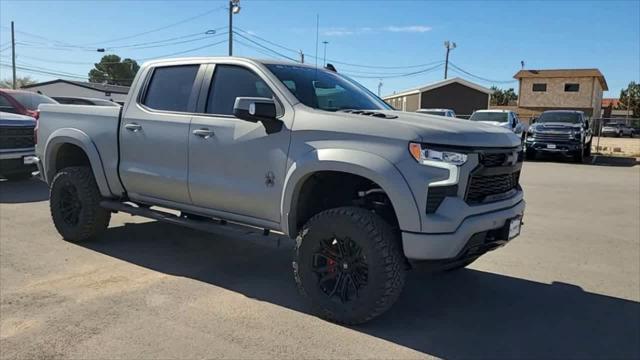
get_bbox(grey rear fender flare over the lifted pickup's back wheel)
[43,128,112,197]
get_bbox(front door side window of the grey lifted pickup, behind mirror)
[205,65,273,115]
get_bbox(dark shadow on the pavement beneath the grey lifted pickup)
[82,222,640,358]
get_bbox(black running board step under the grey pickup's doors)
[100,200,287,246]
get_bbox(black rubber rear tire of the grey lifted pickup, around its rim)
[49,167,111,242]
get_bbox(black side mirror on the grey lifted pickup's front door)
[233,97,282,134]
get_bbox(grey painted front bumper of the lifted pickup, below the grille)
[402,200,525,260]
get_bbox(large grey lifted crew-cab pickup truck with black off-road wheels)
[37,57,525,324]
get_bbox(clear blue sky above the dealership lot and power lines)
[0,0,640,97]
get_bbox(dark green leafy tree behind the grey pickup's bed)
[89,55,140,86]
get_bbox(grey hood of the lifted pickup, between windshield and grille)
[381,111,521,147]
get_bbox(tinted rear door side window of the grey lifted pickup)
[143,65,200,112]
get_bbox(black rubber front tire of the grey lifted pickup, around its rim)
[293,207,406,325]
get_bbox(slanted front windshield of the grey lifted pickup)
[266,64,392,111]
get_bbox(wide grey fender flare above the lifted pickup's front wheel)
[280,149,421,237]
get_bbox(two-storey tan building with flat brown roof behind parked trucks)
[514,69,609,117]
